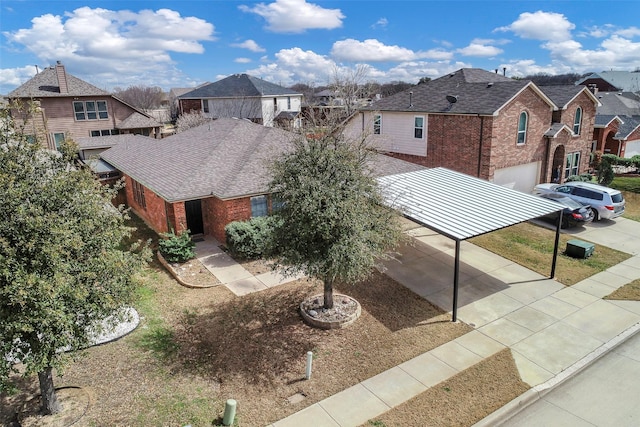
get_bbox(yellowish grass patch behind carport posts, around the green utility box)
[469,222,631,286]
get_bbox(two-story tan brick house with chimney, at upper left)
[7,62,162,149]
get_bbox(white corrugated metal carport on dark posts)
[378,168,562,322]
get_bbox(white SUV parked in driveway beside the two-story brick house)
[533,181,625,221]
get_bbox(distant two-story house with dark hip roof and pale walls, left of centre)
[178,74,303,126]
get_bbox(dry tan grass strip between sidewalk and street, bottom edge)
[365,349,529,427]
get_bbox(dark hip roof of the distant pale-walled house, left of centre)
[179,74,302,99]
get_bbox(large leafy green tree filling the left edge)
[0,102,148,414]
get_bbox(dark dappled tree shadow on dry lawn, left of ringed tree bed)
[172,285,326,386]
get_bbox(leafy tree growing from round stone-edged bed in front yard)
[271,122,401,309]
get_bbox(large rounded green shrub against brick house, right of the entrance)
[224,217,275,259]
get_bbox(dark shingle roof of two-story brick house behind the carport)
[363,68,556,115]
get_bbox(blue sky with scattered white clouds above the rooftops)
[0,0,640,94]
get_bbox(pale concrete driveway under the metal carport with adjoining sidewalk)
[264,222,640,427]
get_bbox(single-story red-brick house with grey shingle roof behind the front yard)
[101,118,423,242]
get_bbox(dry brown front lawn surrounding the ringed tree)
[0,263,490,427]
